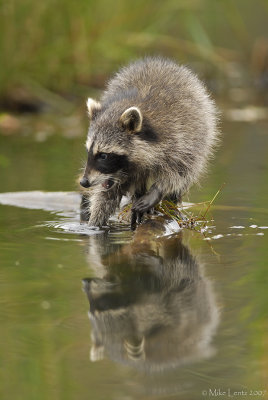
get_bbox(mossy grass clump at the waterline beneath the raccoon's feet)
[118,183,225,229]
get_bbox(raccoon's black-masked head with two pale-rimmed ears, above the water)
[80,99,142,190]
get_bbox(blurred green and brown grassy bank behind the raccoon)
[0,0,268,110]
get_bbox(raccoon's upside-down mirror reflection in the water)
[84,225,218,371]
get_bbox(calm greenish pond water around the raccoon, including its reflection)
[0,113,268,400]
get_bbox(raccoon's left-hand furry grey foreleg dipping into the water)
[88,186,122,226]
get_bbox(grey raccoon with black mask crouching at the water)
[80,58,218,227]
